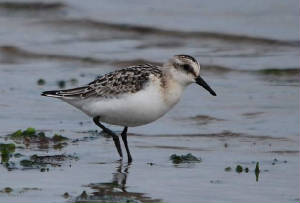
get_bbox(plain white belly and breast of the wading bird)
[66,81,181,127]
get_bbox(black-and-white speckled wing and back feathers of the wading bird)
[56,64,163,99]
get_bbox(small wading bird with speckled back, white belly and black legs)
[42,55,216,162]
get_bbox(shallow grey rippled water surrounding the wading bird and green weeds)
[0,0,299,202]
